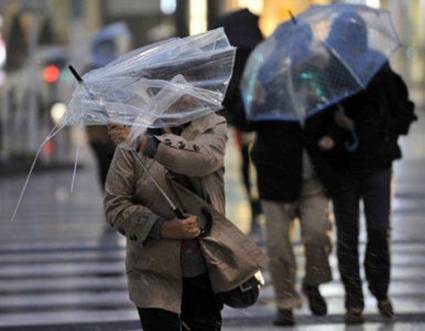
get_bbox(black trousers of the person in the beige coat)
[138,274,223,331]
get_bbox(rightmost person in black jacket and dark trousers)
[315,12,416,323]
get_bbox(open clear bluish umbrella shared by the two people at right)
[241,4,400,121]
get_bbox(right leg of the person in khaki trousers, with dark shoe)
[299,179,332,315]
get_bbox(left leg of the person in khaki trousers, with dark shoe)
[262,200,301,325]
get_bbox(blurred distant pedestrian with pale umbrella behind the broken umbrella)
[82,22,131,190]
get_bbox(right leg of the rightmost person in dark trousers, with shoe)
[362,168,394,317]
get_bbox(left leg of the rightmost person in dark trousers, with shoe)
[333,174,364,323]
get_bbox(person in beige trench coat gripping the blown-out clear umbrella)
[105,114,263,331]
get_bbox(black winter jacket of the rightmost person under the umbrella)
[319,64,417,192]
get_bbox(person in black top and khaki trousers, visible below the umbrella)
[251,118,332,325]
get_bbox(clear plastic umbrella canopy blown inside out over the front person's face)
[64,28,235,143]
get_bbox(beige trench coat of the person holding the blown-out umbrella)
[105,114,265,313]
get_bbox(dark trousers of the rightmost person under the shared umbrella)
[333,168,392,309]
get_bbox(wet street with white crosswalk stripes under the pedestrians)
[0,107,425,331]
